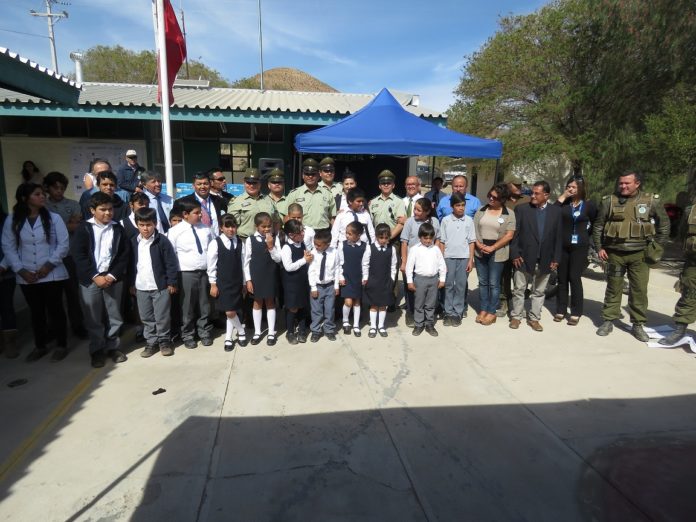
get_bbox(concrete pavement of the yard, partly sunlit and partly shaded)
[0,262,696,521]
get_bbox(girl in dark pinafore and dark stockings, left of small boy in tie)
[280,219,314,344]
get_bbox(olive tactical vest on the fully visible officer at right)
[604,192,660,242]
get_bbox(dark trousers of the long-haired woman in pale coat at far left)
[19,281,68,350]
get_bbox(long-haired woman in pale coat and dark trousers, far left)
[2,183,69,362]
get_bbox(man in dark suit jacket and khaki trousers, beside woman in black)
[510,181,562,332]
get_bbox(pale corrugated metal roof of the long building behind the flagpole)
[0,82,445,118]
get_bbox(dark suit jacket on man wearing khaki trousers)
[510,203,563,274]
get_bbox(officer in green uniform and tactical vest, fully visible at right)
[592,170,669,342]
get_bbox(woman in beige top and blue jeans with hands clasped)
[474,183,516,326]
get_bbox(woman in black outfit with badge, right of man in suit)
[553,176,597,326]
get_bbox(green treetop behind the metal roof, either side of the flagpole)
[82,45,230,87]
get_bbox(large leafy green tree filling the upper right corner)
[449,0,696,193]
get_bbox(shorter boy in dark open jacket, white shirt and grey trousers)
[131,207,179,357]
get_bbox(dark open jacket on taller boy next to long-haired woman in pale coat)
[70,222,131,286]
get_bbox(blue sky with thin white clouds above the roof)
[0,0,547,110]
